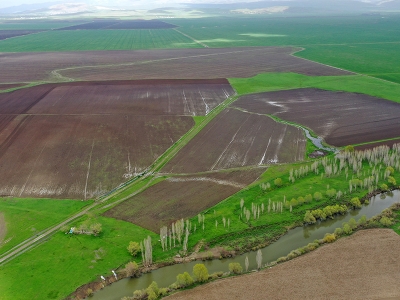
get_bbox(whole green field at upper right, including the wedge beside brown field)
[173,15,400,82]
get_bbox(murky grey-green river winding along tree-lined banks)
[91,191,400,300]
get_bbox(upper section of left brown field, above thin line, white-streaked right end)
[29,79,234,116]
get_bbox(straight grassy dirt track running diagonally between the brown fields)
[0,90,241,265]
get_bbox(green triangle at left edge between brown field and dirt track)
[0,198,92,254]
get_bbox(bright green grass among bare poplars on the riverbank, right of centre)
[182,150,400,252]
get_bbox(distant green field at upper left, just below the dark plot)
[0,29,202,52]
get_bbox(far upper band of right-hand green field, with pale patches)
[170,15,400,47]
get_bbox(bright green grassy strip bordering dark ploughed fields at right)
[229,73,400,103]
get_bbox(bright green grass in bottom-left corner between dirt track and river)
[0,217,162,300]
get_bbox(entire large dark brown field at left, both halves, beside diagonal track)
[0,79,238,199]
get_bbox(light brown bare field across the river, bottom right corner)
[167,229,400,300]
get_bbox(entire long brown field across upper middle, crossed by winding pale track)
[0,47,350,83]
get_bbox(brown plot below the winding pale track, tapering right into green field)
[59,47,351,80]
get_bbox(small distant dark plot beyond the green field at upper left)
[58,20,177,30]
